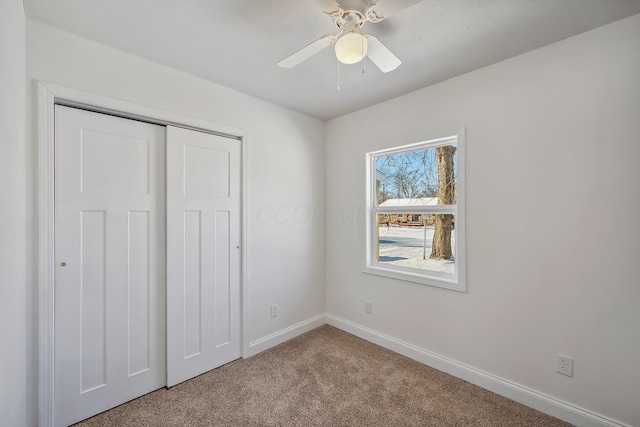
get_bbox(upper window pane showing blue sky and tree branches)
[374,144,457,206]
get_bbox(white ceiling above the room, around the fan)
[24,0,640,120]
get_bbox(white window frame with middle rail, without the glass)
[363,128,467,292]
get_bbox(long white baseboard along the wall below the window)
[326,314,631,427]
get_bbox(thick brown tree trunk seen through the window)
[429,145,456,259]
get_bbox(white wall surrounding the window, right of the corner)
[325,15,640,425]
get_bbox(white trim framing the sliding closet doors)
[37,81,250,427]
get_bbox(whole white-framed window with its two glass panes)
[364,130,466,292]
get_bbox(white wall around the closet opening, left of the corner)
[27,20,325,422]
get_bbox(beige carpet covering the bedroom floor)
[77,326,569,427]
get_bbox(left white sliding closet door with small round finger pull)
[54,106,166,426]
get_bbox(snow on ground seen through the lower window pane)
[379,226,455,274]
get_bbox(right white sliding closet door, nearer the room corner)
[167,126,240,386]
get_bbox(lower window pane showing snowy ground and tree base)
[377,213,456,274]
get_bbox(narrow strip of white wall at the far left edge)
[0,0,26,427]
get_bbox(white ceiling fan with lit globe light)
[278,0,422,73]
